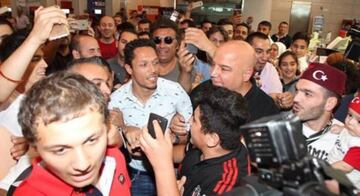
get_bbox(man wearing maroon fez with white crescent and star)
[292,64,346,160]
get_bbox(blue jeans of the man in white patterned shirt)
[130,168,156,196]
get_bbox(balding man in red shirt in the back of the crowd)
[98,16,117,59]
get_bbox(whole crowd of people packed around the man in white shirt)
[0,4,360,196]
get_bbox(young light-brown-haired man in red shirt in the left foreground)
[14,72,131,195]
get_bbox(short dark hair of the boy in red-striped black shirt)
[198,86,250,150]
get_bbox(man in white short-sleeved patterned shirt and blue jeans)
[109,39,192,196]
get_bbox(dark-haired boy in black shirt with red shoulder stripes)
[179,87,250,196]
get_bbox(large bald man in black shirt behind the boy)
[190,41,279,121]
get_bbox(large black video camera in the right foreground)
[231,114,356,195]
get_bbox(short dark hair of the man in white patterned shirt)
[124,39,156,66]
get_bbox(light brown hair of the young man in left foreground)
[18,71,108,144]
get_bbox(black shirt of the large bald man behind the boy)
[190,80,280,121]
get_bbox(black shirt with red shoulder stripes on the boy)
[179,145,250,196]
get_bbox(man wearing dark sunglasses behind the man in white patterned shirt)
[150,18,195,92]
